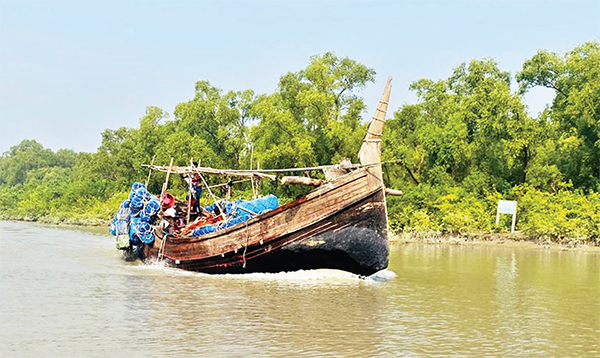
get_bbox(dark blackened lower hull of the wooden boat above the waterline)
[155,190,388,276]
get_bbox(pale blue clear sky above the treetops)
[0,0,600,153]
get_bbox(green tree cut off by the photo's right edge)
[517,42,600,190]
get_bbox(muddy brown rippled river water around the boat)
[0,221,600,357]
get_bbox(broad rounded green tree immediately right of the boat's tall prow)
[384,59,540,190]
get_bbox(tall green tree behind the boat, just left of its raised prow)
[251,52,375,168]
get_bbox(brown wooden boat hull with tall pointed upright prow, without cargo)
[138,78,391,276]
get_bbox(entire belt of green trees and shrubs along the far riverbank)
[0,41,600,249]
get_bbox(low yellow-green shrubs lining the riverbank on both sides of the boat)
[0,185,600,245]
